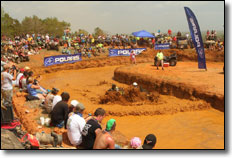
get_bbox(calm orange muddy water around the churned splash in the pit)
[41,66,224,149]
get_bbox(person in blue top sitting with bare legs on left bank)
[27,77,46,101]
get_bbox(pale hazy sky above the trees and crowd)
[1,1,224,34]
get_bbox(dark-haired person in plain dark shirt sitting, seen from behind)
[51,92,70,128]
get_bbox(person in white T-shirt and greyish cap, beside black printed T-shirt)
[67,101,86,148]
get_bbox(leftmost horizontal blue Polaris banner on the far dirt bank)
[44,53,81,66]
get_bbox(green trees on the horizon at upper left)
[1,7,106,37]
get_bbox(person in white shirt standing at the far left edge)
[1,64,16,106]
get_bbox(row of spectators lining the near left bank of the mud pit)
[1,61,156,149]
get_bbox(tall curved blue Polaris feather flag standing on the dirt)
[184,7,207,69]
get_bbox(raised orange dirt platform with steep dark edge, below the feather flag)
[114,62,224,111]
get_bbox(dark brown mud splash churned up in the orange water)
[99,86,159,106]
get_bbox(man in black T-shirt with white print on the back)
[78,108,106,149]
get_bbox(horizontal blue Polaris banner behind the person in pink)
[109,48,147,57]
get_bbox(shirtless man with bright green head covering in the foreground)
[93,119,116,149]
